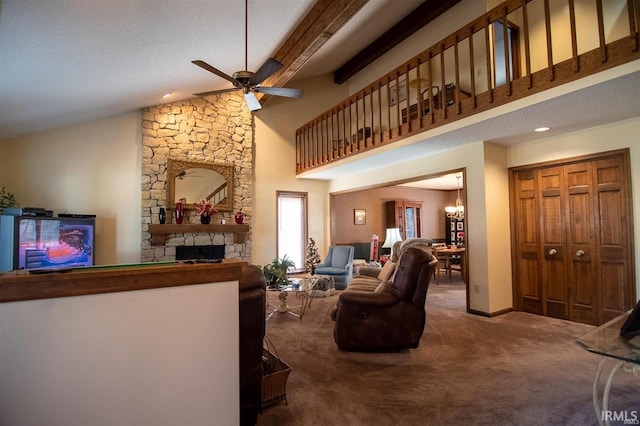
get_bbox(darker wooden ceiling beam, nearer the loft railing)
[333,0,460,84]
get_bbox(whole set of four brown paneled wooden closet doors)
[511,150,636,325]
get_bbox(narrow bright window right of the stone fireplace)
[276,191,307,270]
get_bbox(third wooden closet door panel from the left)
[564,162,598,324]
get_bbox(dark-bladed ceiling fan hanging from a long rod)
[191,0,302,111]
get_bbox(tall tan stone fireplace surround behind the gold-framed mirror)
[141,93,254,262]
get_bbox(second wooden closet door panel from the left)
[539,167,569,319]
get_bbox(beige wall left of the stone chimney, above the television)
[0,112,142,264]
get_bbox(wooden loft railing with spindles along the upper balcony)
[296,0,640,174]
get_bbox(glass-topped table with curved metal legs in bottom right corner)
[575,311,640,426]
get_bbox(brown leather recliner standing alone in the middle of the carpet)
[332,247,438,352]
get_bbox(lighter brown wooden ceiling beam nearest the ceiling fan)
[257,0,369,102]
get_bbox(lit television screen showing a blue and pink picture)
[14,217,95,269]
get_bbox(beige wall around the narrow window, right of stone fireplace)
[252,75,348,265]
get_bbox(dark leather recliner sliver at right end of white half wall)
[239,265,266,426]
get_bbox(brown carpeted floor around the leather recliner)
[258,280,640,426]
